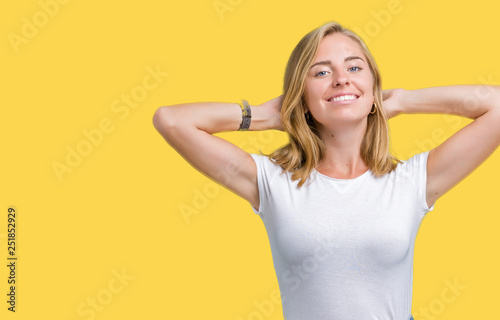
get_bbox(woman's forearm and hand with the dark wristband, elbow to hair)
[153,102,276,134]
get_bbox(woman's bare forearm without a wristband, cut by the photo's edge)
[400,85,500,119]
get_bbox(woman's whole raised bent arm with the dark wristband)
[153,96,282,214]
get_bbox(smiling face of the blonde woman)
[304,33,374,126]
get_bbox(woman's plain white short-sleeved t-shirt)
[251,151,434,320]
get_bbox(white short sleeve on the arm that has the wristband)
[250,153,276,215]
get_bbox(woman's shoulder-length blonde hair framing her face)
[261,22,401,187]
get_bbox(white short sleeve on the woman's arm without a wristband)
[405,150,435,216]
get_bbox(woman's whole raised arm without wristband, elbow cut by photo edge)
[383,85,500,206]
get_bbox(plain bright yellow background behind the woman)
[0,0,500,320]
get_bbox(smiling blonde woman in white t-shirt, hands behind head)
[153,22,500,320]
